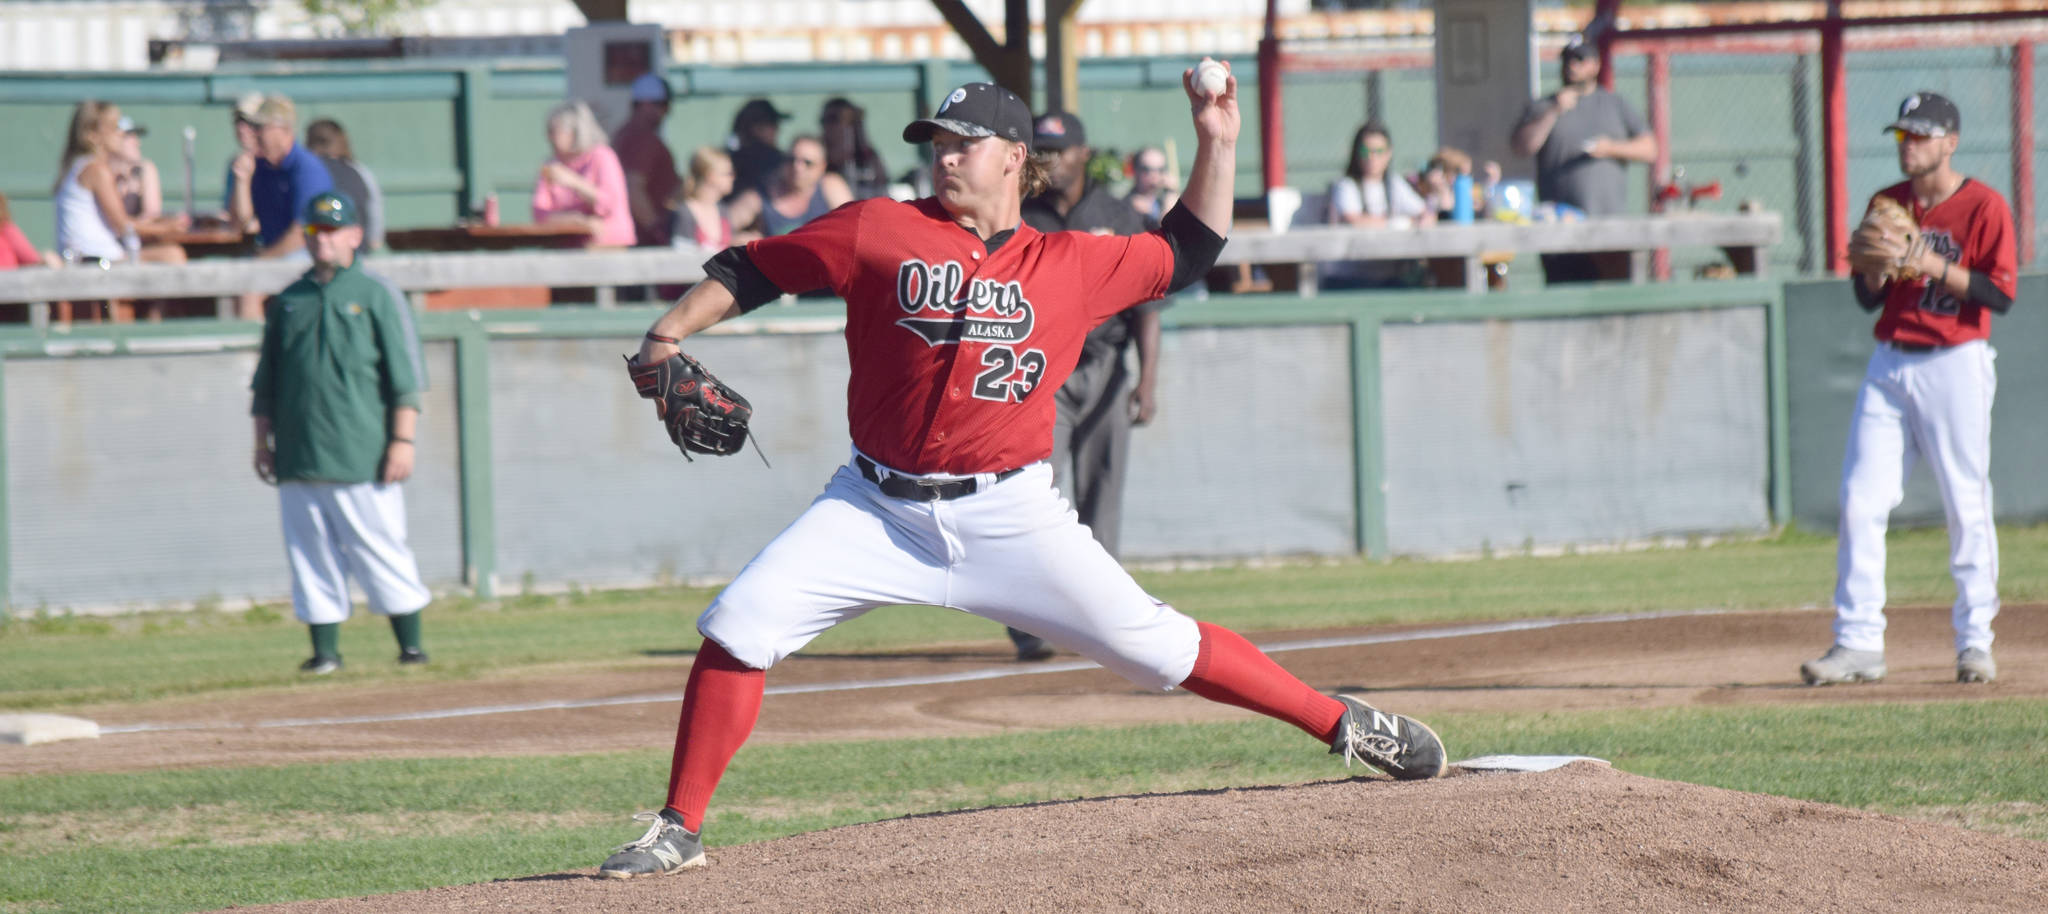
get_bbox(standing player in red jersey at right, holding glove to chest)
[1800,92,2017,684]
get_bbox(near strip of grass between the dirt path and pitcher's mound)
[0,701,2048,912]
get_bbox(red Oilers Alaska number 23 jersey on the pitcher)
[748,197,1174,475]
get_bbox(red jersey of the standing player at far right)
[1874,178,2019,346]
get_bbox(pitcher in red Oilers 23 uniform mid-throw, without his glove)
[598,70,1444,877]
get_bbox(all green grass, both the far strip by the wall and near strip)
[0,527,2048,914]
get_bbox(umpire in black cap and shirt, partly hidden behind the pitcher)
[1010,111,1171,660]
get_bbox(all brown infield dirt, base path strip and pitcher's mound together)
[0,607,2048,914]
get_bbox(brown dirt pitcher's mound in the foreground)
[228,762,2048,914]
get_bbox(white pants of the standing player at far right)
[1835,340,1999,652]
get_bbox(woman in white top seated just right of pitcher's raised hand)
[1321,121,1436,289]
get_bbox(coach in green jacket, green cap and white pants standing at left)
[250,193,432,674]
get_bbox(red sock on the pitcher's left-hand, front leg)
[668,637,768,832]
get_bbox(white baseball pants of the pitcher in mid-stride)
[696,452,1202,689]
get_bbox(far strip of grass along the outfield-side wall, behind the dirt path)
[0,527,2048,709]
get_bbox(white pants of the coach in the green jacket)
[276,482,434,625]
